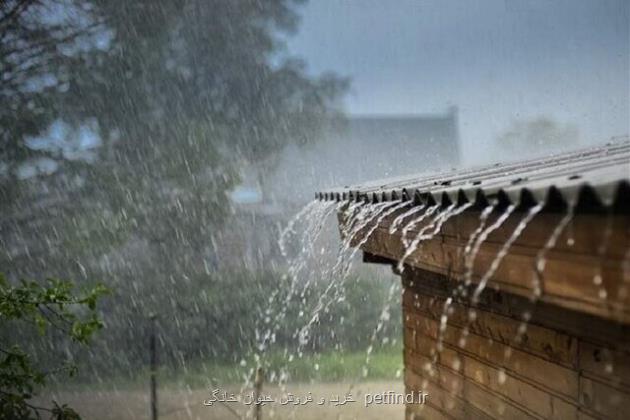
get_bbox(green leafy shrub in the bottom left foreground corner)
[0,274,107,419]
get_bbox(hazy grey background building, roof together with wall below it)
[225,107,460,268]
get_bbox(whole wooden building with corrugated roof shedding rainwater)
[317,141,630,419]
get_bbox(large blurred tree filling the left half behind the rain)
[0,0,347,374]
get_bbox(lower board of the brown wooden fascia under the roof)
[362,226,630,323]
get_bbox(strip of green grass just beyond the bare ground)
[57,345,403,390]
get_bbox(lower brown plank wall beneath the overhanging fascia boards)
[403,267,630,419]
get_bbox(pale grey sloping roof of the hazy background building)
[266,107,460,204]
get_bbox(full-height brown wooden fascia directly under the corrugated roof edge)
[344,208,630,323]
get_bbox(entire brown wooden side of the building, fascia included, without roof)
[339,203,630,420]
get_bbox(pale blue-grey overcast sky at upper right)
[287,0,630,161]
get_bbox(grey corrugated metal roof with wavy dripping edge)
[315,137,630,213]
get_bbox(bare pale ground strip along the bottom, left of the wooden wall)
[42,380,405,420]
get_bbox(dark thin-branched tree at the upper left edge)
[0,0,103,202]
